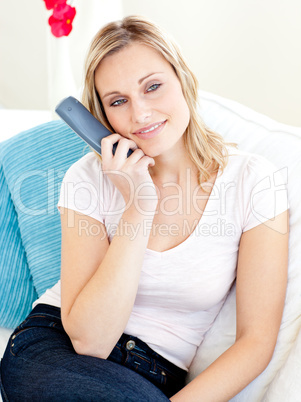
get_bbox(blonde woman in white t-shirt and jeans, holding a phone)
[1,16,288,402]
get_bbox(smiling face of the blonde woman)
[95,42,190,157]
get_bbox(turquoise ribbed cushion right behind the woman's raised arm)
[0,121,90,326]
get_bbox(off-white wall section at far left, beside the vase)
[0,0,47,109]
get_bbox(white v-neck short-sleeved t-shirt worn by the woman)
[34,148,288,370]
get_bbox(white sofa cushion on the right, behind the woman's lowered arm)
[188,91,301,402]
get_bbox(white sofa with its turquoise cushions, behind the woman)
[0,91,301,402]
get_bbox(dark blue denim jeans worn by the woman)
[0,304,187,402]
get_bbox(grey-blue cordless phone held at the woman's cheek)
[55,96,133,157]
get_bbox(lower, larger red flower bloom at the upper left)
[48,2,76,38]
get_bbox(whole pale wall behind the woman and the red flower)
[0,0,301,126]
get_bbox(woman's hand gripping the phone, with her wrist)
[101,134,158,212]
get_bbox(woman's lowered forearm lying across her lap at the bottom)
[170,338,274,402]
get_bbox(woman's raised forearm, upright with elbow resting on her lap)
[64,209,153,357]
